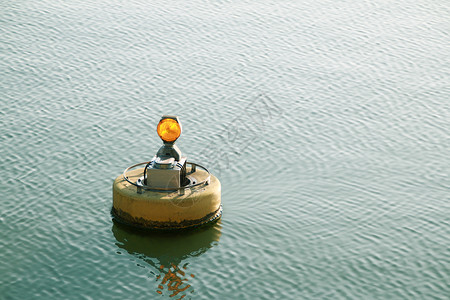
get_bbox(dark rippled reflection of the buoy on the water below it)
[112,220,221,299]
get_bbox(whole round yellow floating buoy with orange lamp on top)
[111,115,222,230]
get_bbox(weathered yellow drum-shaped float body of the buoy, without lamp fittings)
[113,168,221,228]
